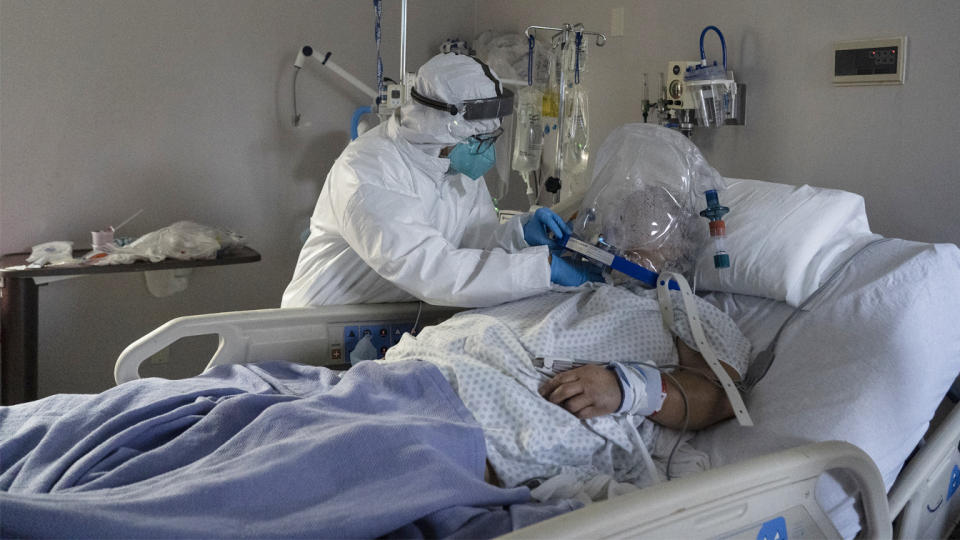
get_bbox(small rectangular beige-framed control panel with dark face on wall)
[833,36,907,86]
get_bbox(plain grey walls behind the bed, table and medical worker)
[0,0,960,395]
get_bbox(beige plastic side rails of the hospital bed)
[114,302,960,540]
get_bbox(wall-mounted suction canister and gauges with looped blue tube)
[643,26,747,137]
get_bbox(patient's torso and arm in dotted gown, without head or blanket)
[383,285,750,500]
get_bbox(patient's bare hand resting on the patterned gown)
[540,365,623,420]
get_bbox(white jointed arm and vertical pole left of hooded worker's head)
[293,0,412,139]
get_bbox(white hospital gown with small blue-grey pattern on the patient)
[383,286,750,499]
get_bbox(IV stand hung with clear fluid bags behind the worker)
[513,23,607,204]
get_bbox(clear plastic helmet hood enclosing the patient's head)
[574,124,725,282]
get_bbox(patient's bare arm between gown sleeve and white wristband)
[648,339,740,430]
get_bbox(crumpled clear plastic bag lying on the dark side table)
[94,217,245,266]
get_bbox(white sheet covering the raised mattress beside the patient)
[693,240,960,538]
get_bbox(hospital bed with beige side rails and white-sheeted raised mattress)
[109,197,960,539]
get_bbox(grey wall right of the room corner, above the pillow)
[477,0,960,243]
